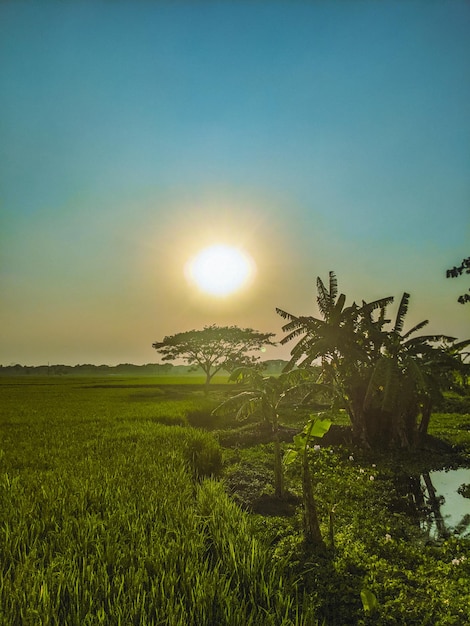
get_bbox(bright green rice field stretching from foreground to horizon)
[0,377,316,626]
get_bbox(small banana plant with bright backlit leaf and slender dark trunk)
[284,415,331,549]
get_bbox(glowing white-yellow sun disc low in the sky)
[185,244,255,296]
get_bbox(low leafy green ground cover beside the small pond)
[272,434,470,626]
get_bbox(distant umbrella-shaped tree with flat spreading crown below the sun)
[152,324,275,390]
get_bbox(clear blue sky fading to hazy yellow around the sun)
[0,0,470,365]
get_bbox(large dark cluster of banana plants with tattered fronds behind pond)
[277,272,470,447]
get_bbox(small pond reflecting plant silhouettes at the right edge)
[393,468,470,539]
